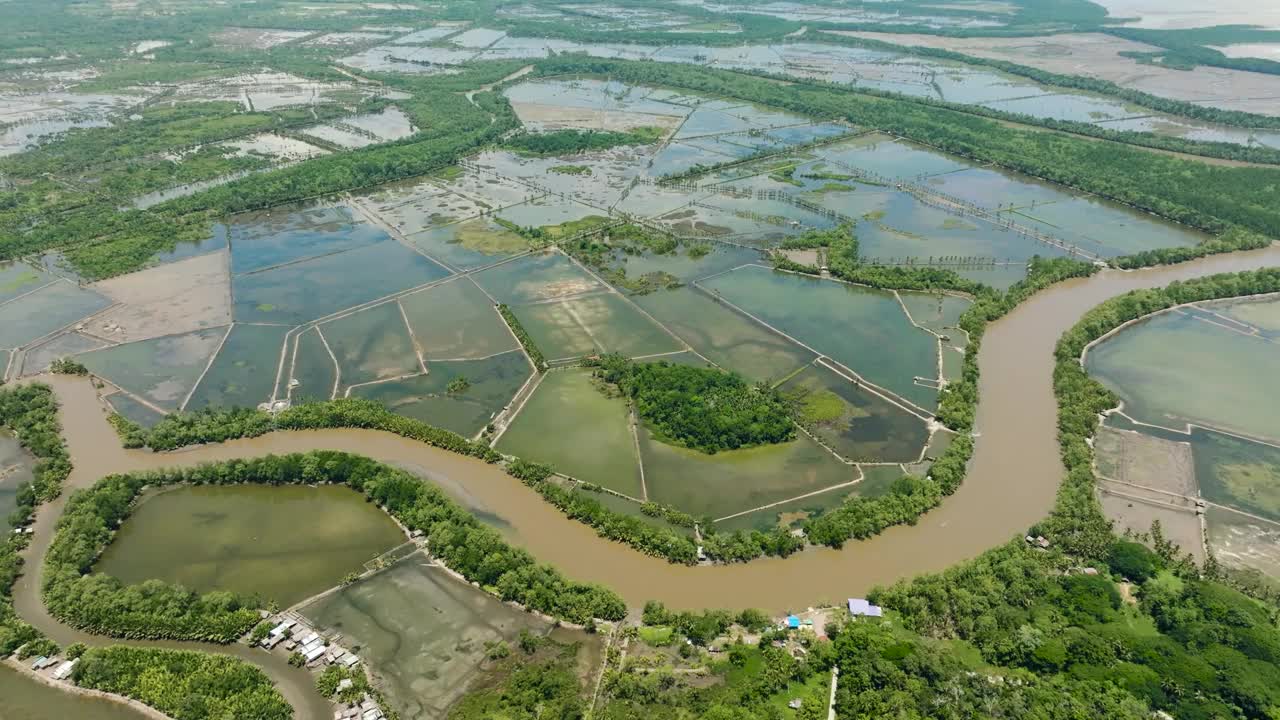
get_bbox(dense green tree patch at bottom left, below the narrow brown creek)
[74,647,293,720]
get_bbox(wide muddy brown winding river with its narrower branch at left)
[7,245,1280,720]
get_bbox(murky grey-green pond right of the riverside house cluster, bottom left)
[302,555,560,720]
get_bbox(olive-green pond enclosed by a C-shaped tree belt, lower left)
[93,486,404,607]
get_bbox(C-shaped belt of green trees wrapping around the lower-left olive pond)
[42,451,626,643]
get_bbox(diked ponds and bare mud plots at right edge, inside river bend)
[1087,297,1280,577]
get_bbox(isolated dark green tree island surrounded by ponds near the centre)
[590,354,795,454]
